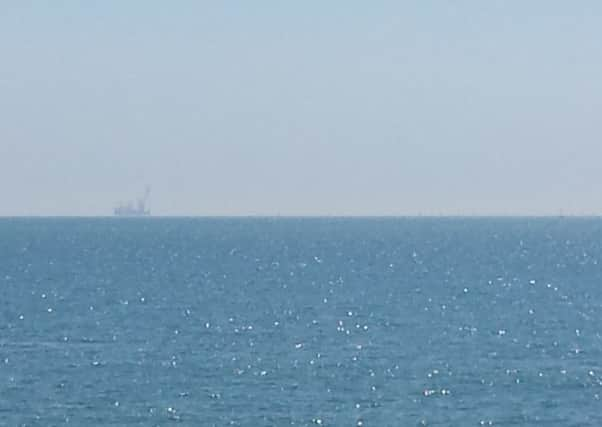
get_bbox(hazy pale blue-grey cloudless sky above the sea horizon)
[0,0,602,216]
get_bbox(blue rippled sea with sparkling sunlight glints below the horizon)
[0,218,602,426]
